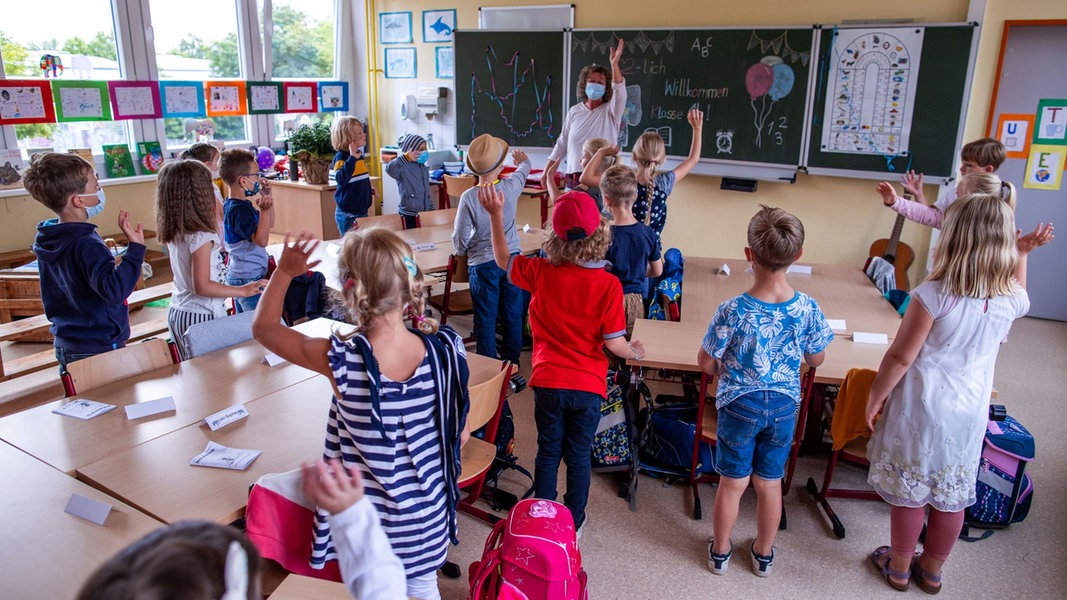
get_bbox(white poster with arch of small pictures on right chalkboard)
[822,28,924,156]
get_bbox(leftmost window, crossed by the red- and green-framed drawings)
[0,0,130,155]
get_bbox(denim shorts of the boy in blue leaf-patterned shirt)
[715,391,797,479]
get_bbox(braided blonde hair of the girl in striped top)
[337,227,437,333]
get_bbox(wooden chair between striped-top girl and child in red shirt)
[458,361,514,525]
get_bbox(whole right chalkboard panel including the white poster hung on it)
[807,23,974,178]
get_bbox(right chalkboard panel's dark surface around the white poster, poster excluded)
[805,23,977,183]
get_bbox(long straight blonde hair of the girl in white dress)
[928,193,1019,299]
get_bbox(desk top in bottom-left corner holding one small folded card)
[0,442,162,598]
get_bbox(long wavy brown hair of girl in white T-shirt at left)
[156,158,219,243]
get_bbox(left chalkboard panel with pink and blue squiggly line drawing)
[453,30,564,147]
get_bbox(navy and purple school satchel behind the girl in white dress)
[959,415,1034,541]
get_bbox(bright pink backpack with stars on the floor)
[469,499,589,600]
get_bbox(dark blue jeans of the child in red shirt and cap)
[534,388,603,530]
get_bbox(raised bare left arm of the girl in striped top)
[252,232,333,380]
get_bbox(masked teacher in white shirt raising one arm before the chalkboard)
[541,37,626,188]
